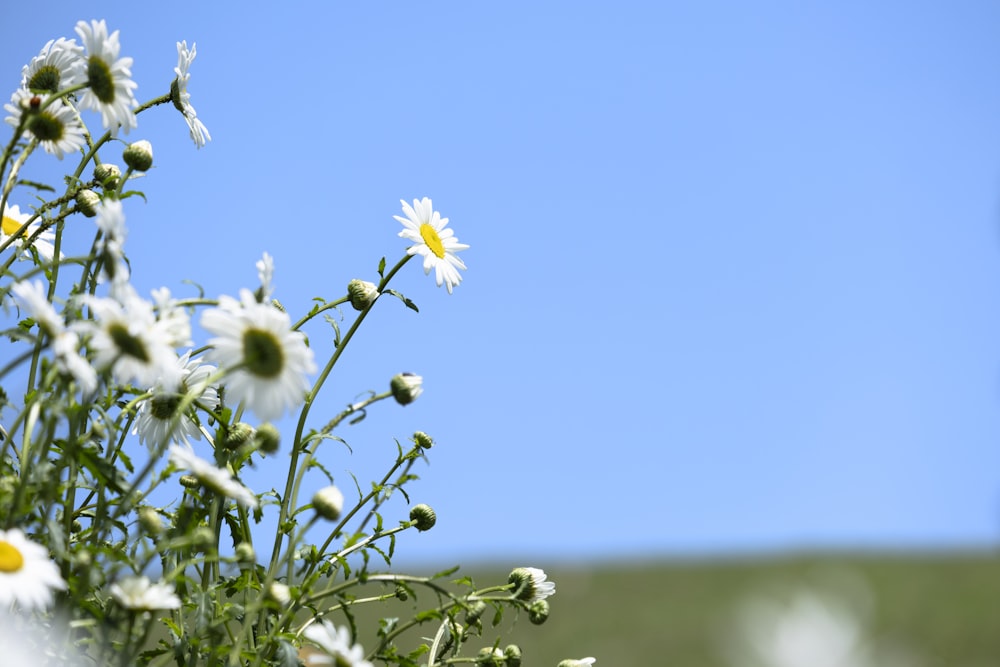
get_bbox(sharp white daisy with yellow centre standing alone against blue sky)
[392,197,469,294]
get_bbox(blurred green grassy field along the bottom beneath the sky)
[362,554,1000,667]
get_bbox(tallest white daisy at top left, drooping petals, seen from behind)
[76,20,137,135]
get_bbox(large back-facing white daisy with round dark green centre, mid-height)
[201,289,316,421]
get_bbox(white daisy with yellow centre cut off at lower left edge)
[0,528,66,611]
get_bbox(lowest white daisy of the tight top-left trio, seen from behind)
[3,88,86,160]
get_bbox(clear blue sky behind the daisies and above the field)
[0,1,1000,563]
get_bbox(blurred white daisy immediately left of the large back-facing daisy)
[75,283,178,387]
